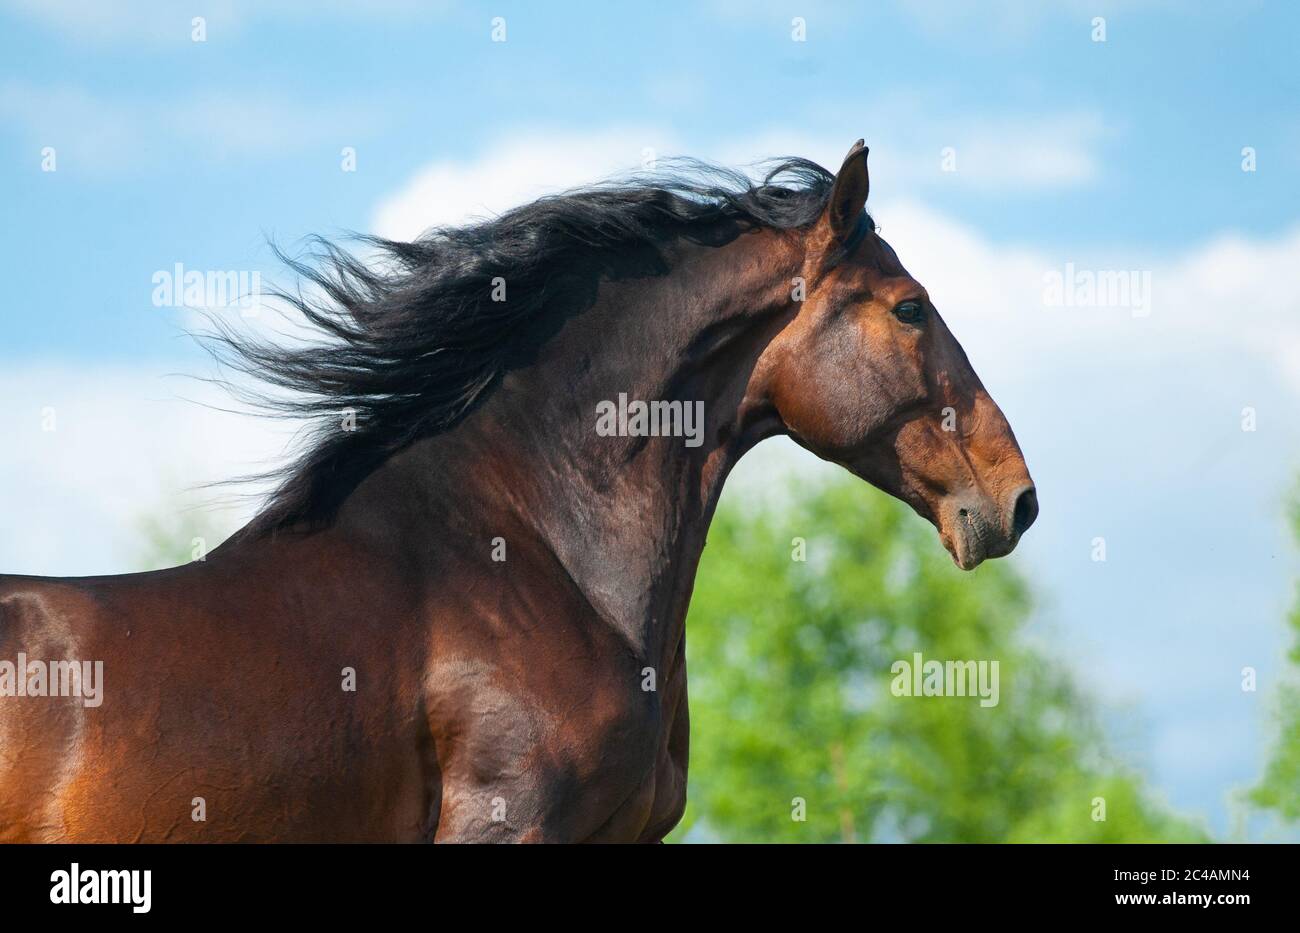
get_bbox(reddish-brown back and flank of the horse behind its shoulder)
[0,541,428,842]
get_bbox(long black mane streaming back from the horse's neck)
[204,159,835,533]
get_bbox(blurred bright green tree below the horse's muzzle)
[672,481,1205,842]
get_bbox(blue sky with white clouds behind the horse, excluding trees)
[0,0,1300,838]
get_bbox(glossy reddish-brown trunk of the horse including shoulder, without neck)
[0,488,681,842]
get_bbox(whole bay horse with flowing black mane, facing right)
[0,140,1037,842]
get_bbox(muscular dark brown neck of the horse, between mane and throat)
[379,231,800,663]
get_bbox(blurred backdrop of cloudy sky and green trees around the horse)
[0,0,1300,842]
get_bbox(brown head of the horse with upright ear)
[759,140,1039,570]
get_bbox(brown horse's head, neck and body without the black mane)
[0,142,1036,841]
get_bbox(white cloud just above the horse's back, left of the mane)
[0,363,293,574]
